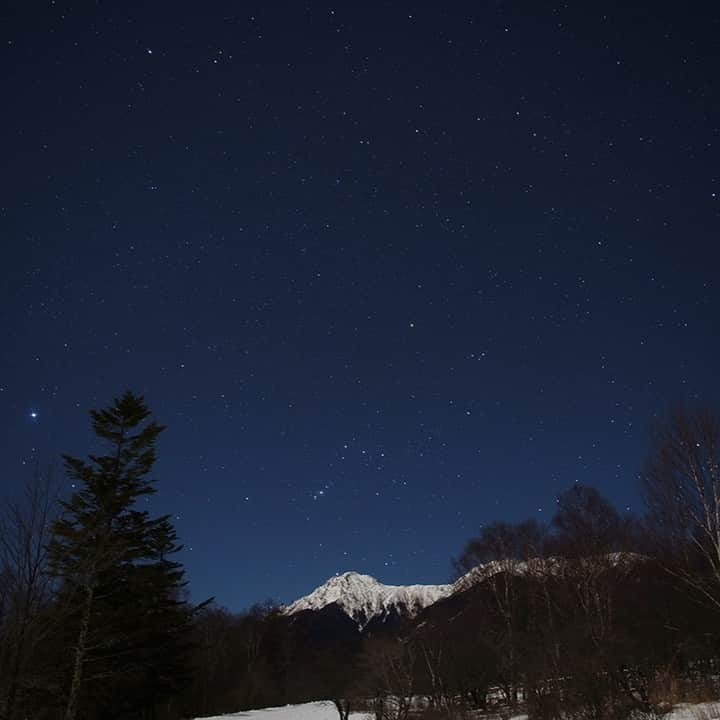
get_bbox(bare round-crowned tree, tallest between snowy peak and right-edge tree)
[534,485,660,720]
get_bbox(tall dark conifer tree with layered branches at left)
[49,392,191,720]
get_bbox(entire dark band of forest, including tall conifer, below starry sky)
[0,392,720,720]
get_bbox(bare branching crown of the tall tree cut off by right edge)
[642,407,720,609]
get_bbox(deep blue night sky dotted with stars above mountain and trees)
[0,0,720,610]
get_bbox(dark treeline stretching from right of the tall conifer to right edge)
[176,409,720,720]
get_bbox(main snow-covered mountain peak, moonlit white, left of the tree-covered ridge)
[283,572,454,629]
